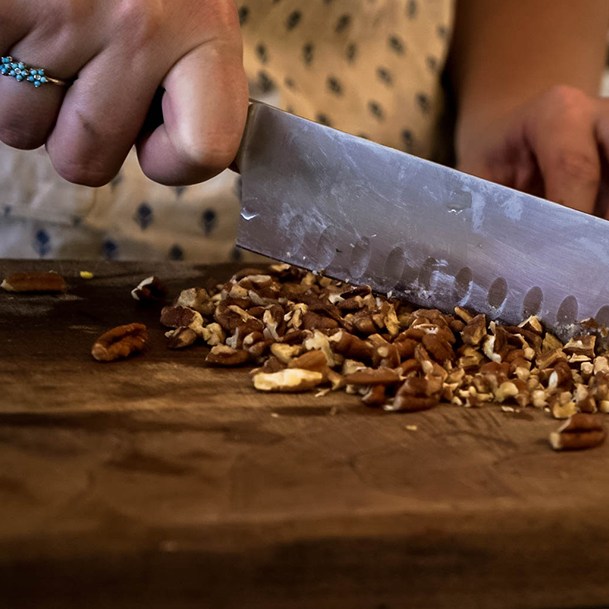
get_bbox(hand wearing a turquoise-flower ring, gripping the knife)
[0,0,247,186]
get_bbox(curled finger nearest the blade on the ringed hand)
[138,39,248,185]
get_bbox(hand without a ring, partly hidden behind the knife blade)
[457,87,609,218]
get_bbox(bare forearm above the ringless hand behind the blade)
[449,0,609,145]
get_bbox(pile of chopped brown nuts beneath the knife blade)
[161,264,609,432]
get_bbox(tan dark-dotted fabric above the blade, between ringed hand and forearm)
[238,0,454,158]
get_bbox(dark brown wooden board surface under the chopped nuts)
[0,261,609,609]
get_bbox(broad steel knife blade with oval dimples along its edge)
[237,102,609,339]
